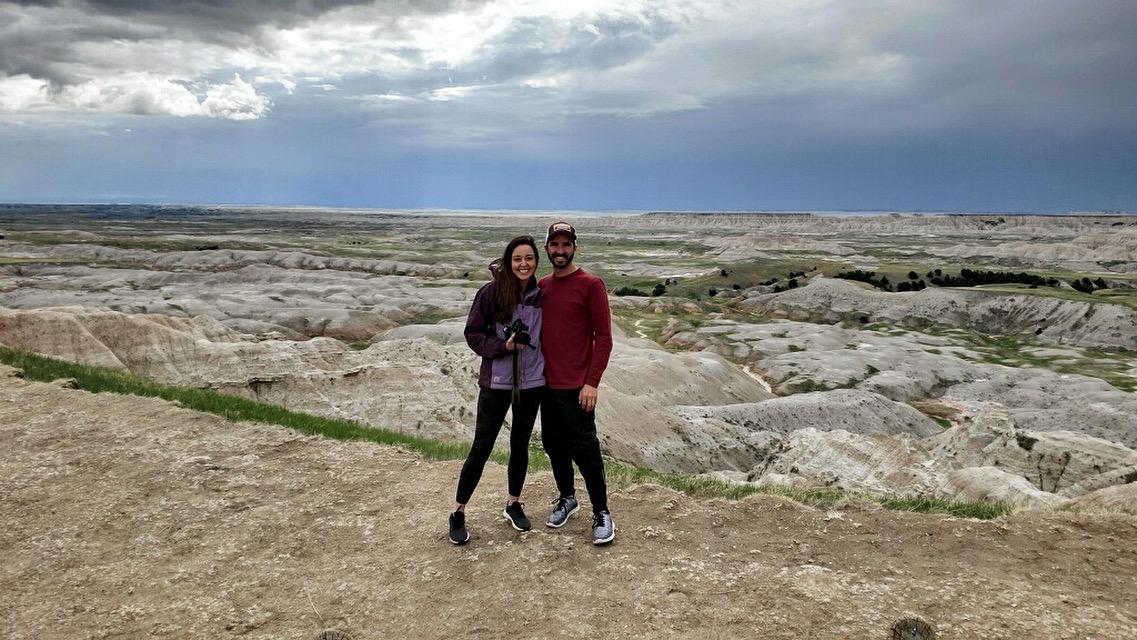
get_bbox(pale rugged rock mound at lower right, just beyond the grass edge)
[746,405,1137,507]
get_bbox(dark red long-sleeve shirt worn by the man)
[538,268,612,389]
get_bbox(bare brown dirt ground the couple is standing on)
[0,369,1137,640]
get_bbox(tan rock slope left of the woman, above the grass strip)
[0,308,478,439]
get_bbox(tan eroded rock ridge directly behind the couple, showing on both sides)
[0,308,770,471]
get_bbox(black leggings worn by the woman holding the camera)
[455,387,545,505]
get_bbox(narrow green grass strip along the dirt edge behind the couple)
[0,346,1011,520]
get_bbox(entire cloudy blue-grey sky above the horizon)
[0,0,1137,211]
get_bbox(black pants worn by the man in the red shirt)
[541,389,608,513]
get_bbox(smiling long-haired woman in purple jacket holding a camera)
[450,235,545,545]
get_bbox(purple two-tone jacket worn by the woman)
[465,277,545,390]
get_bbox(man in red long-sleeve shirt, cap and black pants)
[538,222,616,545]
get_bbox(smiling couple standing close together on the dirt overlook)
[450,222,616,545]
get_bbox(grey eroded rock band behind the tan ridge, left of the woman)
[0,259,474,340]
